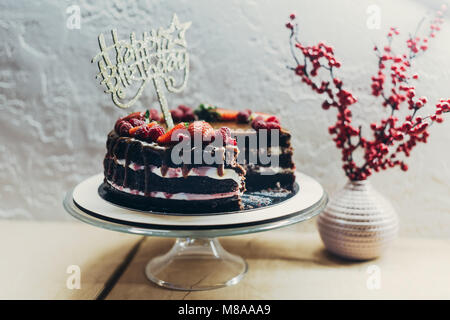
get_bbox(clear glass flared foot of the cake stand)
[145,238,247,291]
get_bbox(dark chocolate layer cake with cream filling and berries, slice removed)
[104,105,295,213]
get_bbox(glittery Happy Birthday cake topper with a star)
[92,14,191,128]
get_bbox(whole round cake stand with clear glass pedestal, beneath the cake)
[63,172,328,291]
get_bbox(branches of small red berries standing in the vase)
[286,6,450,181]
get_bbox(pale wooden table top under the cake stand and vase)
[0,220,450,299]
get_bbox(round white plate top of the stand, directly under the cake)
[72,172,327,230]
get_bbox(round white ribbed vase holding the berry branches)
[317,180,398,260]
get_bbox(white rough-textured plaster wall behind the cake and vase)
[0,0,450,237]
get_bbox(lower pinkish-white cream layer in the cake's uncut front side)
[108,181,240,201]
